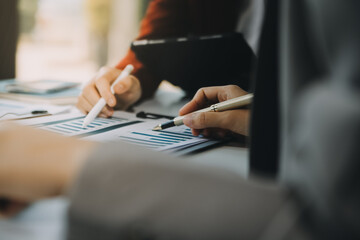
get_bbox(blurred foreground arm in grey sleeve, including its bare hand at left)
[0,124,288,240]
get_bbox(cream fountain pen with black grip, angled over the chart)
[152,93,254,131]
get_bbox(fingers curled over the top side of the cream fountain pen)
[179,85,247,115]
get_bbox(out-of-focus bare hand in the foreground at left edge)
[0,123,95,215]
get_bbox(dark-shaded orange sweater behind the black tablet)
[116,0,248,99]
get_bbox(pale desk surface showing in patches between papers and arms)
[0,89,248,240]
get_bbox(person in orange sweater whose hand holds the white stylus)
[77,0,256,117]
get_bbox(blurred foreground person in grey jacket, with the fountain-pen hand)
[0,0,360,239]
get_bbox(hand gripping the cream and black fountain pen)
[179,85,250,138]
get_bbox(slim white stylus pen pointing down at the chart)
[82,64,134,128]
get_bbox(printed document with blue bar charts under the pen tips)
[23,112,219,155]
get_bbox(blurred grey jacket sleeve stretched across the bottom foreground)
[68,143,287,240]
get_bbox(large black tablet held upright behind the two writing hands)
[131,33,255,96]
